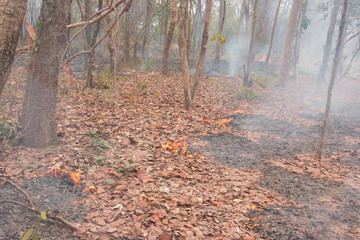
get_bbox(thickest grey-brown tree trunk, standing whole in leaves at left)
[21,0,71,147]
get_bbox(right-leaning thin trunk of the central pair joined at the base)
[191,0,212,105]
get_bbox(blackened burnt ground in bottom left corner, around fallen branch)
[0,177,87,239]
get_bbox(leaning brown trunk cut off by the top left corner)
[0,0,27,97]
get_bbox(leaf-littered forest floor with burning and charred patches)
[0,54,360,240]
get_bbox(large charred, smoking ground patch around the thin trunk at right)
[197,78,360,239]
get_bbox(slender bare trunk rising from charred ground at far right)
[316,0,348,159]
